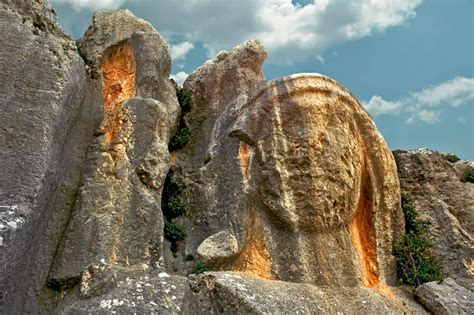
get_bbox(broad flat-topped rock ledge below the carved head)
[183,272,426,314]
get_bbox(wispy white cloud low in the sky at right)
[363,77,474,124]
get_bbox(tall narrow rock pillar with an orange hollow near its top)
[49,10,179,287]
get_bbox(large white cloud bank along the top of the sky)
[124,0,423,62]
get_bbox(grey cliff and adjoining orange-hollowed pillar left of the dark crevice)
[0,1,179,313]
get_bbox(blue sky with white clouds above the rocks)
[50,0,474,160]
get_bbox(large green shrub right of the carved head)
[393,194,443,287]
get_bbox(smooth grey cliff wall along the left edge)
[0,0,100,314]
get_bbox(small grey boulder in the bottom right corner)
[415,278,474,315]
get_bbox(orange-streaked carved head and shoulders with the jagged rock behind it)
[176,41,403,287]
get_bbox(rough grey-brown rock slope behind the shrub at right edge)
[394,149,474,291]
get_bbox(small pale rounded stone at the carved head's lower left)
[196,231,239,266]
